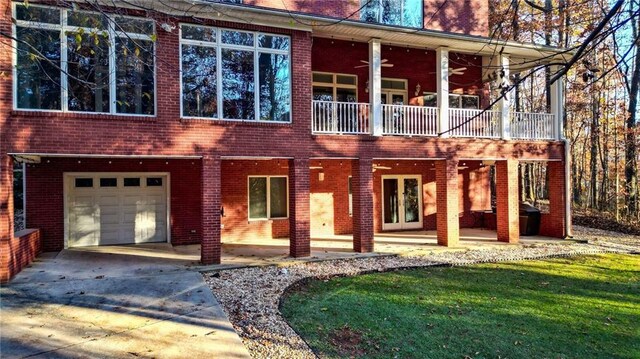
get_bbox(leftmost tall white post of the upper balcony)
[369,39,383,136]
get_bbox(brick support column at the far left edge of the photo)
[0,155,15,282]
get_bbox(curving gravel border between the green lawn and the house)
[203,226,640,358]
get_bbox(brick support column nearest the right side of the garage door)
[200,155,222,264]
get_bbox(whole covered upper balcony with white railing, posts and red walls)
[312,38,562,140]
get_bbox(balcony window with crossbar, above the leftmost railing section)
[313,72,358,102]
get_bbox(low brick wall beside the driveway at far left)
[0,229,42,283]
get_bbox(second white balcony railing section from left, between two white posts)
[382,105,438,136]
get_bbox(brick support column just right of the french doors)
[435,160,460,247]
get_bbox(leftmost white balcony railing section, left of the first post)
[312,101,371,135]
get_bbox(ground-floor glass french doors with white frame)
[382,175,422,230]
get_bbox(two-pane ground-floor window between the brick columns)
[249,176,289,219]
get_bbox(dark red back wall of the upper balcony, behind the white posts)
[311,37,483,102]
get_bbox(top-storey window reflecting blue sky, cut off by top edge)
[360,0,423,27]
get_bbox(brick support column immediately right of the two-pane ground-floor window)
[289,158,311,257]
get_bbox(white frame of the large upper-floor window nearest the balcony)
[178,23,293,123]
